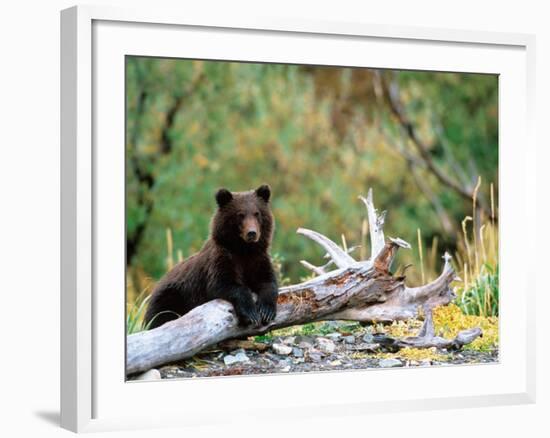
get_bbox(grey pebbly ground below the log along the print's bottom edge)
[146,331,498,379]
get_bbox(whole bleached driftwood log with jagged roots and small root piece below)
[126,190,481,374]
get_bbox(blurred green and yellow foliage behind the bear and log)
[126,57,498,326]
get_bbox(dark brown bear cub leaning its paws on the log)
[145,185,277,329]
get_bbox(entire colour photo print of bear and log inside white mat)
[125,56,499,380]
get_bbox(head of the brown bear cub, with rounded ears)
[212,184,274,251]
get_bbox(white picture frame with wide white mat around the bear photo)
[61,6,536,432]
